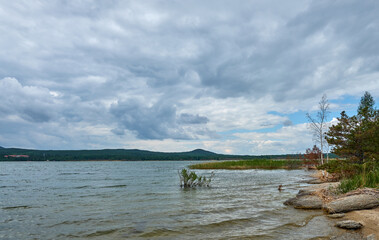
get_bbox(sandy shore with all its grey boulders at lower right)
[284,174,379,240]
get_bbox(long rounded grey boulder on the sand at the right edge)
[324,194,379,213]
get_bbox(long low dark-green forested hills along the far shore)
[0,148,312,161]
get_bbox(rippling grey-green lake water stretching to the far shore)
[0,161,342,239]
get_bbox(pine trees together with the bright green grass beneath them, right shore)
[319,92,379,193]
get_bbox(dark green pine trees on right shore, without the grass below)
[326,92,379,163]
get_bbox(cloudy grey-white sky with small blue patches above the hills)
[0,0,379,155]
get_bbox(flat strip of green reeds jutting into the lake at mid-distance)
[189,159,301,170]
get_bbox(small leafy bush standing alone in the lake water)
[178,168,214,188]
